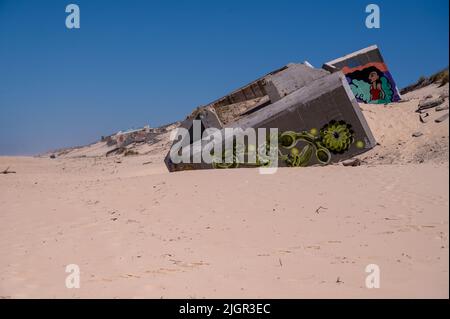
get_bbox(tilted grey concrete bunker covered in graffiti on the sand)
[165,47,400,171]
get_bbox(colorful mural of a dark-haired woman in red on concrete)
[342,62,400,104]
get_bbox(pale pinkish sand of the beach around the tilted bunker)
[0,86,449,298]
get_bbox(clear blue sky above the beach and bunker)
[0,0,449,155]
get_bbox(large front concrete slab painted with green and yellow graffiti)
[165,72,376,171]
